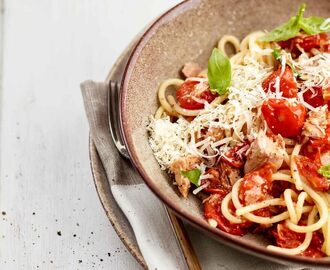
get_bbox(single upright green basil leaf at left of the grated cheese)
[207,48,231,95]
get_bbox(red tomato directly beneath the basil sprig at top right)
[278,33,329,58]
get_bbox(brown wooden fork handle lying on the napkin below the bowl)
[165,207,202,270]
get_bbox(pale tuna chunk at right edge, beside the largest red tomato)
[302,106,328,139]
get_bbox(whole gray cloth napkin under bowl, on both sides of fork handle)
[81,81,322,270]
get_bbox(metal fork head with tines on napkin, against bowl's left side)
[108,81,129,159]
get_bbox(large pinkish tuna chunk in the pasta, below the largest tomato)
[244,131,287,173]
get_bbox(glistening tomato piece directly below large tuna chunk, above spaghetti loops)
[239,164,274,217]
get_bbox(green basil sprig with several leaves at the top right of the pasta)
[259,4,330,41]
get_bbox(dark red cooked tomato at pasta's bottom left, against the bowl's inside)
[204,192,250,236]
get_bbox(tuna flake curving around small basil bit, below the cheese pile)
[170,156,202,198]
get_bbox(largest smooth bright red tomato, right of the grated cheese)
[261,99,306,137]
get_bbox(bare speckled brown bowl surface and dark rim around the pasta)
[120,0,330,267]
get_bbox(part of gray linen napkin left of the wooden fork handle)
[81,81,186,269]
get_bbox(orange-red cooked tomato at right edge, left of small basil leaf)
[294,156,330,191]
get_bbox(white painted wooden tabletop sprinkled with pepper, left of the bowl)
[0,0,178,269]
